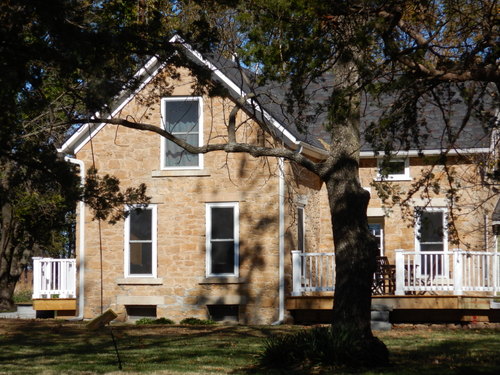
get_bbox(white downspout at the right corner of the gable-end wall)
[272,158,285,325]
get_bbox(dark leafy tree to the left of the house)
[0,0,158,310]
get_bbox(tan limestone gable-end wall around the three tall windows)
[77,68,279,324]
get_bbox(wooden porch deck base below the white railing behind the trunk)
[286,295,500,323]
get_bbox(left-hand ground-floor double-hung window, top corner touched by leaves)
[125,205,156,277]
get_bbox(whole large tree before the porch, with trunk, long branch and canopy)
[103,0,500,364]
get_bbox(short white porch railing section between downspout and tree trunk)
[292,250,335,296]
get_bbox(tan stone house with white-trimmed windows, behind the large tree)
[46,39,498,324]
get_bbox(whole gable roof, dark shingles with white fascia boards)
[59,36,490,159]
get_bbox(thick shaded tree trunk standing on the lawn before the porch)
[320,60,388,366]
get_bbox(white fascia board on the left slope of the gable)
[57,57,165,154]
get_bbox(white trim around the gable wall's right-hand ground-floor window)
[205,202,240,277]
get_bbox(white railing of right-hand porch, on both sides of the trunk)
[292,249,500,296]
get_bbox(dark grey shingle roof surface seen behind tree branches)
[205,51,490,151]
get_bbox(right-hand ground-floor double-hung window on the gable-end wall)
[206,202,239,276]
